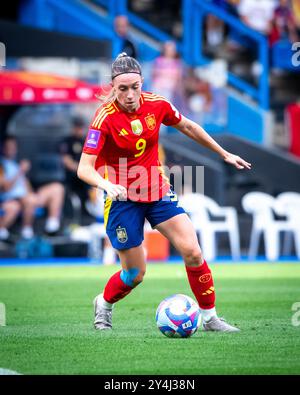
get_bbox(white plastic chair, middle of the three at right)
[242,192,298,261]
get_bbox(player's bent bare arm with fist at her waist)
[77,152,127,199]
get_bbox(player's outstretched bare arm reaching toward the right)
[173,116,251,169]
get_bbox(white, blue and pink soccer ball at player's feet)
[156,294,201,337]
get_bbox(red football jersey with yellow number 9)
[83,92,181,202]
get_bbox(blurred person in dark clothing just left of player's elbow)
[59,116,90,207]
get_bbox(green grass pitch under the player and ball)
[0,262,300,375]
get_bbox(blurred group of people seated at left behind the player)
[0,116,109,241]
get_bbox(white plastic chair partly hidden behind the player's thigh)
[179,193,241,260]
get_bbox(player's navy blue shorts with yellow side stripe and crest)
[104,191,185,250]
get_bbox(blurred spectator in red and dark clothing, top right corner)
[270,0,298,45]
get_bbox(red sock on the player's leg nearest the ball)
[185,261,216,309]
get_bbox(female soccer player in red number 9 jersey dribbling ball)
[77,53,251,332]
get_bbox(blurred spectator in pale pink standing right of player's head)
[151,41,184,106]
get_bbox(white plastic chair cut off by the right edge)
[276,192,300,259]
